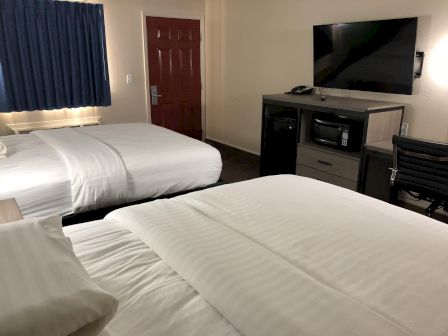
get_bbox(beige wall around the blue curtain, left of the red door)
[0,0,204,135]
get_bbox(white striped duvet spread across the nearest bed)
[67,176,448,336]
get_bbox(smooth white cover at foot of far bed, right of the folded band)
[80,123,222,200]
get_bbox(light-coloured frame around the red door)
[141,11,206,140]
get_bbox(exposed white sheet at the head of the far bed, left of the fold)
[0,134,72,217]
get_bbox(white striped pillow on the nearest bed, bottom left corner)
[0,217,118,336]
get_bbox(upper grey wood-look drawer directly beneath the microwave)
[297,145,359,181]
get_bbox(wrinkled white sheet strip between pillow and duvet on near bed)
[64,220,240,336]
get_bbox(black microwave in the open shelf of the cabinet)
[311,113,364,152]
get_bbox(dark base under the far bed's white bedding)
[62,180,225,226]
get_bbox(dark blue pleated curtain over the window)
[0,0,111,112]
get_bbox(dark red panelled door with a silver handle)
[146,17,202,139]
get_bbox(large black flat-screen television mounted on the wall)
[313,18,417,95]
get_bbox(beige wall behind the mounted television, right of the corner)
[205,0,448,153]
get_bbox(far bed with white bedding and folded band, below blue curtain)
[0,123,222,217]
